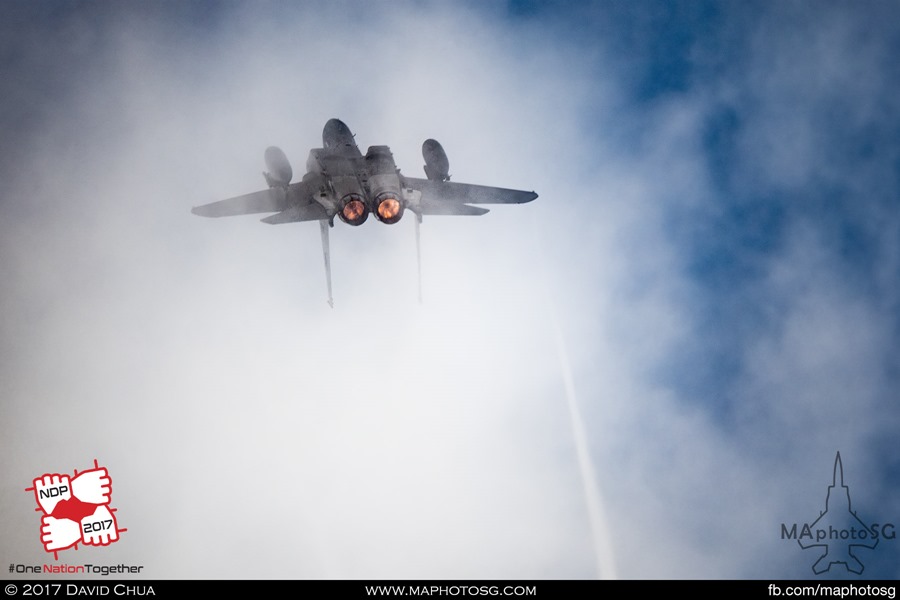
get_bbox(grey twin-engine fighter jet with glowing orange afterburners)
[191,119,537,307]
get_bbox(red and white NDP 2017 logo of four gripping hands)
[25,460,127,558]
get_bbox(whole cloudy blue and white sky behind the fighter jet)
[0,2,900,579]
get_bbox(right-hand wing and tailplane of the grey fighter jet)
[404,177,537,215]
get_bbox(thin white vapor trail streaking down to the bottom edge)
[548,303,616,579]
